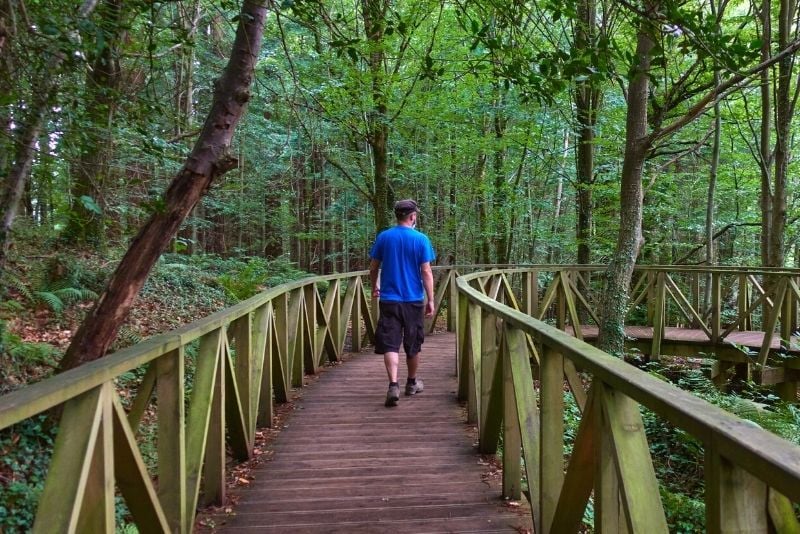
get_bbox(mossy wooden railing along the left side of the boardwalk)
[0,268,466,533]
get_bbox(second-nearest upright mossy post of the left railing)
[156,347,188,532]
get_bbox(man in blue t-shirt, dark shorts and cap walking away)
[369,200,436,407]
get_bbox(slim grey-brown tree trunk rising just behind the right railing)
[598,14,653,356]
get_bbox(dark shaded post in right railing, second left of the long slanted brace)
[479,311,503,454]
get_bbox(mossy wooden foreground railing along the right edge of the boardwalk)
[457,268,800,533]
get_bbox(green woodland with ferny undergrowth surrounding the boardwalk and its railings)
[0,0,800,532]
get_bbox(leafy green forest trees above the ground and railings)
[0,0,798,273]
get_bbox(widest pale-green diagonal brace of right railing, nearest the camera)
[599,388,669,532]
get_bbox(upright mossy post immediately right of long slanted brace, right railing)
[539,347,564,525]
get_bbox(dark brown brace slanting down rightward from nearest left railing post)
[112,394,171,533]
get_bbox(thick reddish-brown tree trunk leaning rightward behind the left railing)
[60,0,267,371]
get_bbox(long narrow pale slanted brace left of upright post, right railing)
[504,325,542,532]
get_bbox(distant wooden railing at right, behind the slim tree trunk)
[486,265,800,400]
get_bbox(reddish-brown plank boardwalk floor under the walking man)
[214,333,531,533]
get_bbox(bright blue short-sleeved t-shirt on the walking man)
[369,225,436,302]
